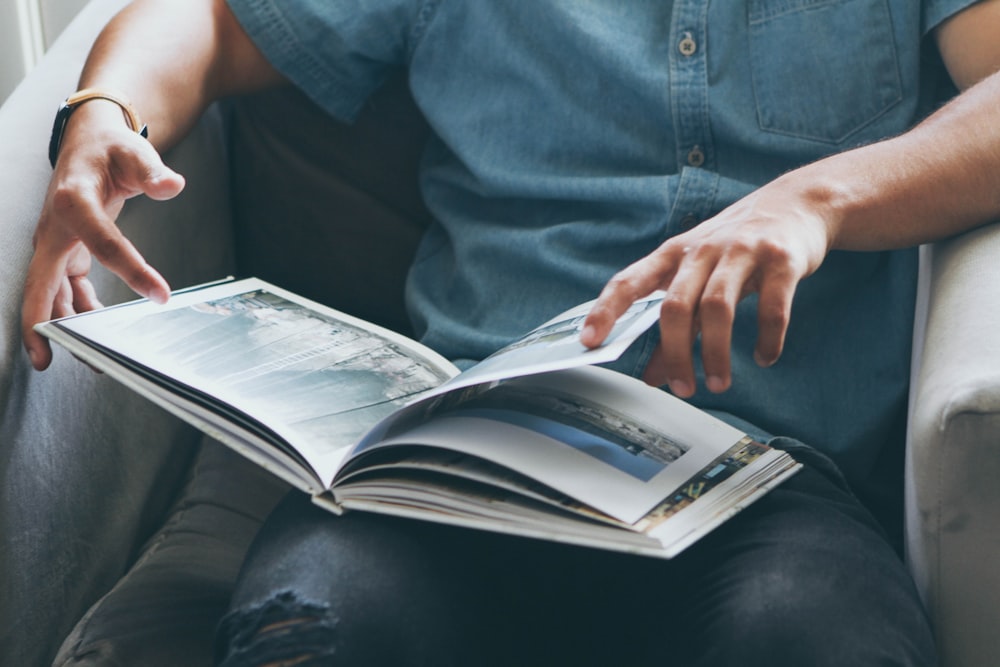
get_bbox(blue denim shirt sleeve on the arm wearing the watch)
[227,0,433,121]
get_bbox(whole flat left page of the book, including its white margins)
[56,279,458,484]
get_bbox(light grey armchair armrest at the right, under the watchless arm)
[907,225,1000,665]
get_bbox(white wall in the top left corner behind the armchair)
[0,0,87,104]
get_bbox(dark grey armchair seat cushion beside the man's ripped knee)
[53,438,288,667]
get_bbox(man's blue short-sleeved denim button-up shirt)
[229,0,973,490]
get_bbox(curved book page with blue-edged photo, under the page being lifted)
[345,366,745,524]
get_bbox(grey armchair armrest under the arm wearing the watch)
[0,0,233,665]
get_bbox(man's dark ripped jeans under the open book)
[211,439,936,667]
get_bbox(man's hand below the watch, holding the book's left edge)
[21,100,184,370]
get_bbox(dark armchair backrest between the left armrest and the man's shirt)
[230,76,429,340]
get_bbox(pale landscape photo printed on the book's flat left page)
[101,290,453,456]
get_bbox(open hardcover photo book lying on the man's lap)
[37,279,798,558]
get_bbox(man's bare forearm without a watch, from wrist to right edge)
[800,74,1000,250]
